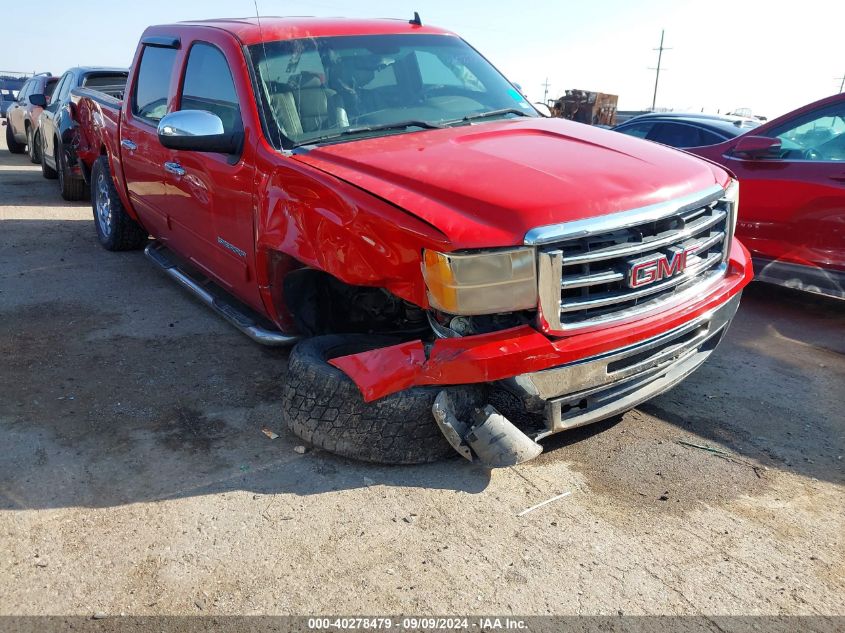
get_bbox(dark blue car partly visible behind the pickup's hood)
[613,112,759,148]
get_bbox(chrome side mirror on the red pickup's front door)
[158,110,244,154]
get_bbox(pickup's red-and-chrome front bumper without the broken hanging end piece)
[330,235,753,402]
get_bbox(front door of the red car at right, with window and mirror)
[725,99,845,270]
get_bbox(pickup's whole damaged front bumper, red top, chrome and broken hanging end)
[330,242,752,467]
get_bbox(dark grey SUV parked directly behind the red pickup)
[35,67,128,200]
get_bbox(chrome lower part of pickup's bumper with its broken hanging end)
[432,294,740,468]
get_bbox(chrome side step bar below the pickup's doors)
[144,242,299,347]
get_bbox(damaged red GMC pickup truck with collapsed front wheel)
[73,17,752,466]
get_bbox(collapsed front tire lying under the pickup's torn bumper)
[282,335,485,464]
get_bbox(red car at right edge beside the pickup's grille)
[689,94,845,299]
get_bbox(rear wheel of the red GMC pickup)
[91,156,148,251]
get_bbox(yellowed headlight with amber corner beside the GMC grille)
[423,248,537,315]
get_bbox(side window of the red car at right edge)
[766,103,845,161]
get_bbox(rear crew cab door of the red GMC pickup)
[119,38,178,241]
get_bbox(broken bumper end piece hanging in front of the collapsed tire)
[431,391,543,468]
